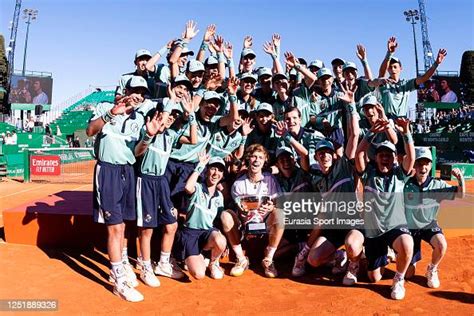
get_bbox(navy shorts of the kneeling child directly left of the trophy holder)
[174,227,217,261]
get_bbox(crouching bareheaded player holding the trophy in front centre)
[221,144,284,278]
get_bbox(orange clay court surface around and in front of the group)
[0,177,474,315]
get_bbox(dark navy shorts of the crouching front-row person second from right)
[365,227,410,271]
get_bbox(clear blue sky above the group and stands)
[0,0,474,111]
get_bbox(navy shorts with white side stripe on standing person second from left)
[137,174,176,228]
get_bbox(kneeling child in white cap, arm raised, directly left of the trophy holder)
[176,154,230,280]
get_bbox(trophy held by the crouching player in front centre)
[240,195,271,235]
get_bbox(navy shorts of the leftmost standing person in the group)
[93,161,136,225]
